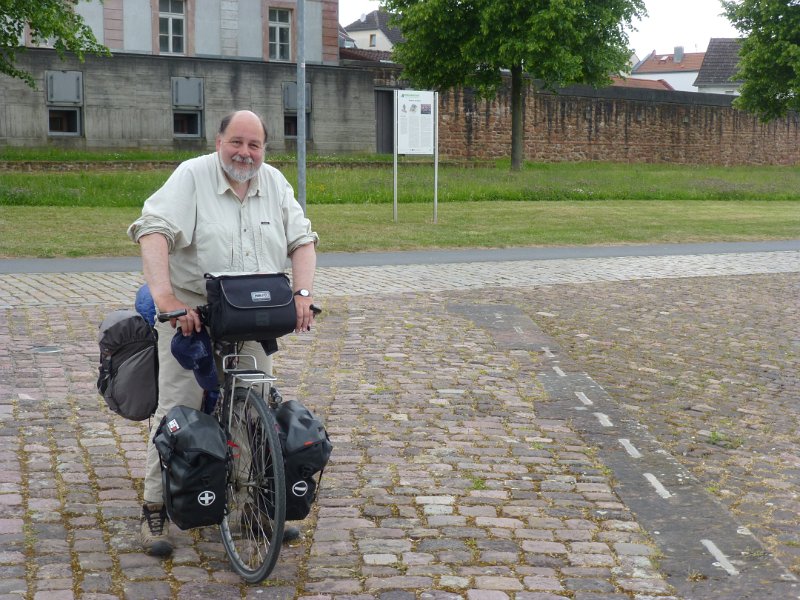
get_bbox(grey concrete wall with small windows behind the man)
[0,49,375,154]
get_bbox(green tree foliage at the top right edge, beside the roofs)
[722,0,800,122]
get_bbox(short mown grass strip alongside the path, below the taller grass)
[0,200,800,258]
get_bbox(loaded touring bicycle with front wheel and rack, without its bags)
[157,305,322,583]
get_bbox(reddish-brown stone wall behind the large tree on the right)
[439,86,800,165]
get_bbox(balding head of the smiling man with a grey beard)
[217,113,264,183]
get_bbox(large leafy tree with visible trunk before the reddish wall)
[382,0,645,170]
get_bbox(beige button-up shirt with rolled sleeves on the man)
[128,152,319,301]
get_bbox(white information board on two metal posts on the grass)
[394,90,439,223]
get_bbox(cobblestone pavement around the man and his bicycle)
[0,252,800,600]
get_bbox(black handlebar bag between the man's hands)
[205,273,297,342]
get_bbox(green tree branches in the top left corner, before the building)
[0,0,109,88]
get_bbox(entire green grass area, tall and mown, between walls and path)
[0,159,800,258]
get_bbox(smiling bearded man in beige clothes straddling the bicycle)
[128,110,319,557]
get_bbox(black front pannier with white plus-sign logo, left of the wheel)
[153,406,228,529]
